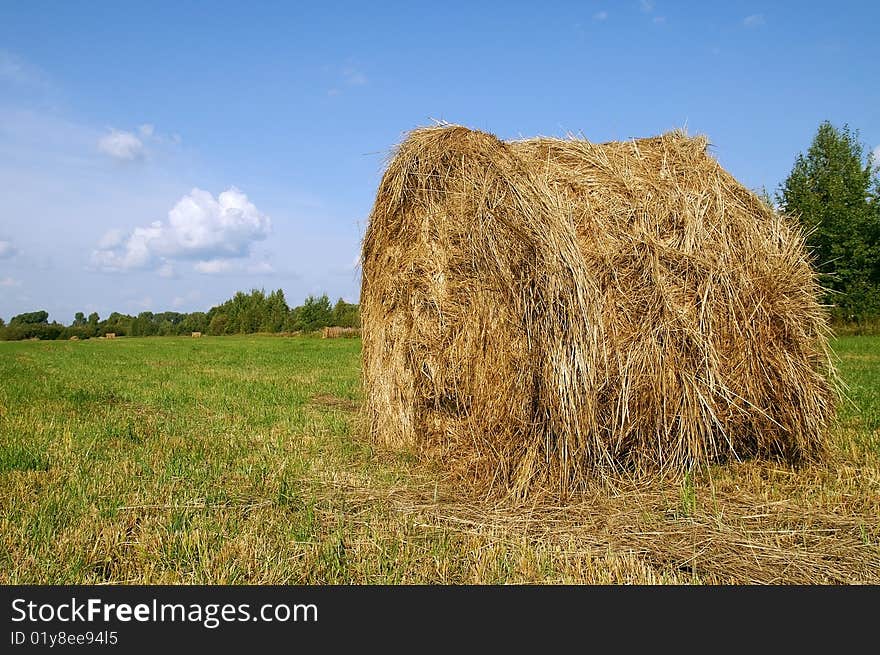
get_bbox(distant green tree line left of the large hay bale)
[0,289,361,341]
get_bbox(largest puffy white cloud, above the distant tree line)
[92,187,271,276]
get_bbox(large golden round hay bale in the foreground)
[361,125,835,494]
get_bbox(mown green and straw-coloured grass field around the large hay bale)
[0,337,880,584]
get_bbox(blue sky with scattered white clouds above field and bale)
[0,0,880,323]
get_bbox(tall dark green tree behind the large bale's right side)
[779,121,880,322]
